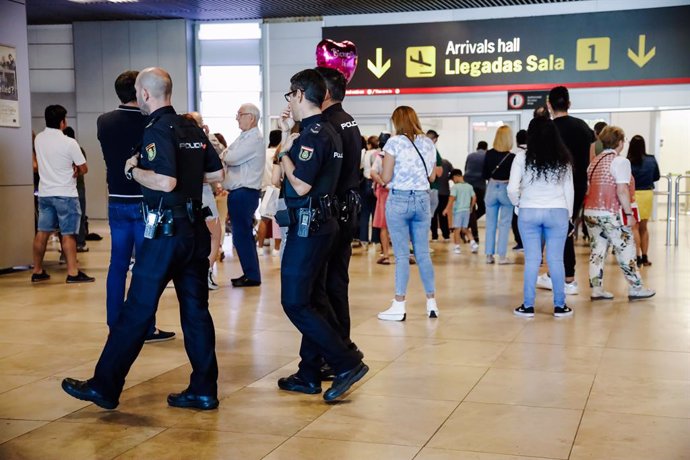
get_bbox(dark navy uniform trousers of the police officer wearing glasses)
[280,219,361,382]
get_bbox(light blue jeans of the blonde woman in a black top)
[484,180,513,257]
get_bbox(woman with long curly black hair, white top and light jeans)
[508,117,575,317]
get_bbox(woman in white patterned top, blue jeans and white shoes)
[378,106,438,321]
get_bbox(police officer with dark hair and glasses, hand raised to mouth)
[276,69,369,401]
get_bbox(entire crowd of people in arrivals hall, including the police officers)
[31,67,659,410]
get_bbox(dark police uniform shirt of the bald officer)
[139,106,223,208]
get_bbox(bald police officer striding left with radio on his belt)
[62,67,223,409]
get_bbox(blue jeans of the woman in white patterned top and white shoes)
[386,190,434,296]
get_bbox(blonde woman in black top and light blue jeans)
[482,125,515,265]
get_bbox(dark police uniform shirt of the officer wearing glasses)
[283,114,343,208]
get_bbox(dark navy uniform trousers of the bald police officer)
[89,218,218,400]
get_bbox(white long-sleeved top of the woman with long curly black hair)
[507,151,575,217]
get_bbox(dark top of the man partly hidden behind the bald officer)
[96,105,146,197]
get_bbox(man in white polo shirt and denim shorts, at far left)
[31,105,94,283]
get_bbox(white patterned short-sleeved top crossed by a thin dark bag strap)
[383,134,436,190]
